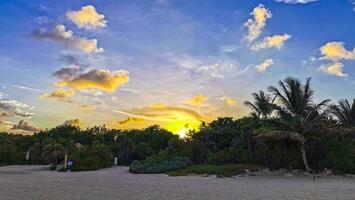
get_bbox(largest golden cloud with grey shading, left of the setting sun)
[57,69,129,93]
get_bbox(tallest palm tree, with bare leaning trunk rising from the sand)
[269,77,329,171]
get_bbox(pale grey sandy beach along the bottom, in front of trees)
[0,166,355,200]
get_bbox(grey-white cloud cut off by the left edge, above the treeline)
[0,94,34,118]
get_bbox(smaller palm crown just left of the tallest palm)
[244,90,274,119]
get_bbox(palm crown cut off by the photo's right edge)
[330,99,355,126]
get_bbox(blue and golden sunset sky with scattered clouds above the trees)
[0,0,355,135]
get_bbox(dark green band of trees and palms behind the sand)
[0,78,355,173]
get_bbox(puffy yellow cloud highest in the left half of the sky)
[66,5,107,29]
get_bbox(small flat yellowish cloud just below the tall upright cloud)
[250,34,291,51]
